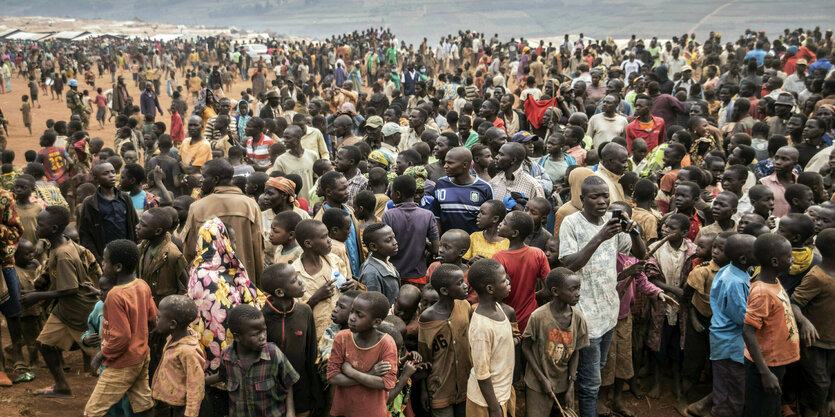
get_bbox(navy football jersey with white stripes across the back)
[431,177,493,234]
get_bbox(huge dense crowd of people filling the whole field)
[0,22,835,417]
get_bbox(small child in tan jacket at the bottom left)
[151,295,206,417]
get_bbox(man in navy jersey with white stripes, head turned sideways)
[432,147,493,234]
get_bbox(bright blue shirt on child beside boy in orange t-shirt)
[710,264,751,363]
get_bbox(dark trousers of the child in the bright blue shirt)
[710,359,745,417]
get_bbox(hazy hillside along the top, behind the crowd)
[2,0,835,45]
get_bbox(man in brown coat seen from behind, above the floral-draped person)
[183,159,264,287]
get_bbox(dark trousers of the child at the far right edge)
[799,345,835,412]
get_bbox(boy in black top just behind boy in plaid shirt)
[261,264,322,413]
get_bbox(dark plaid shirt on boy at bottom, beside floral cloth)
[220,342,299,417]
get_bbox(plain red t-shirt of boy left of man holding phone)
[493,246,551,332]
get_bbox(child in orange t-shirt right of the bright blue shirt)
[742,233,800,417]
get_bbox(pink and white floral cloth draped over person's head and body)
[188,217,266,372]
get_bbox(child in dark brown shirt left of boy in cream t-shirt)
[418,264,472,417]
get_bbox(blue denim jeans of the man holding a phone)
[576,328,615,417]
